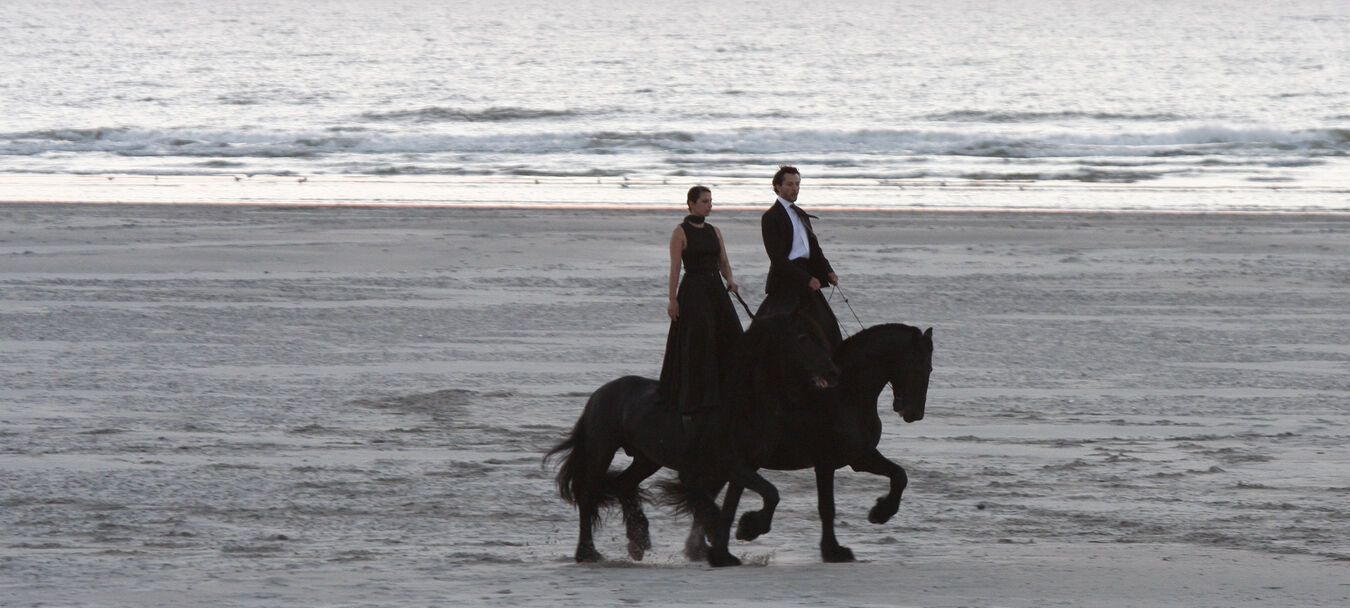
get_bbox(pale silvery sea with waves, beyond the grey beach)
[0,0,1350,212]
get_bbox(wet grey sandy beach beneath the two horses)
[0,204,1350,608]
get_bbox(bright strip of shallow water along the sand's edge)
[0,173,1350,215]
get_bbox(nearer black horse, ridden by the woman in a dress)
[544,313,838,566]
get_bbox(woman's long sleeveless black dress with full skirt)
[660,219,743,415]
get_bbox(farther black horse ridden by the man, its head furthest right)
[666,323,933,562]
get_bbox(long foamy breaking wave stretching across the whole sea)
[0,126,1350,166]
